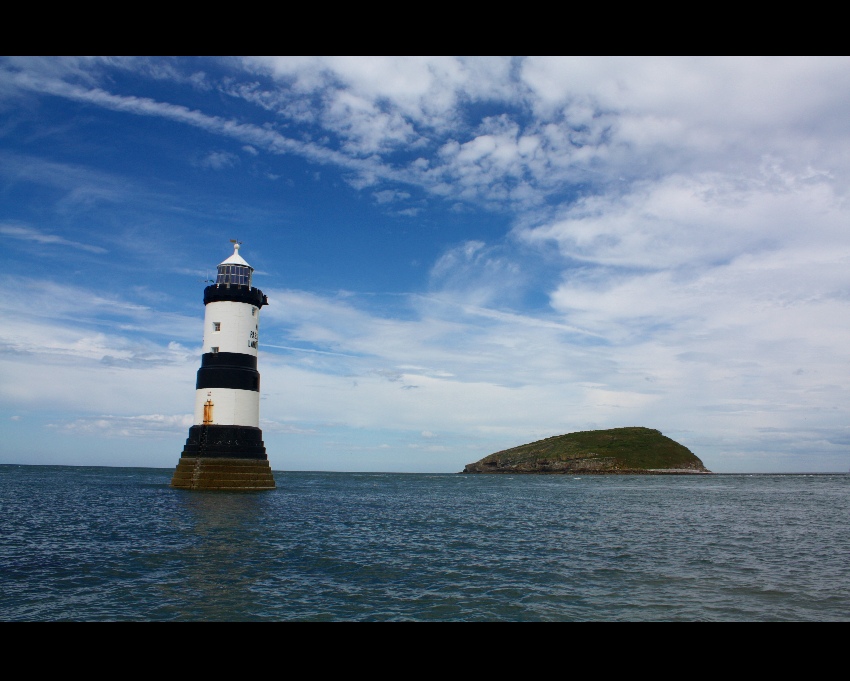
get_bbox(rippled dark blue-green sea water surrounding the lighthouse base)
[0,465,850,622]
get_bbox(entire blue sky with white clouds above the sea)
[0,56,850,473]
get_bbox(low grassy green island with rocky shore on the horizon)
[461,426,711,475]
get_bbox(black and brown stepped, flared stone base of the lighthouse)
[166,425,275,491]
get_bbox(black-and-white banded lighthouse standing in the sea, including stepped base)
[171,239,275,490]
